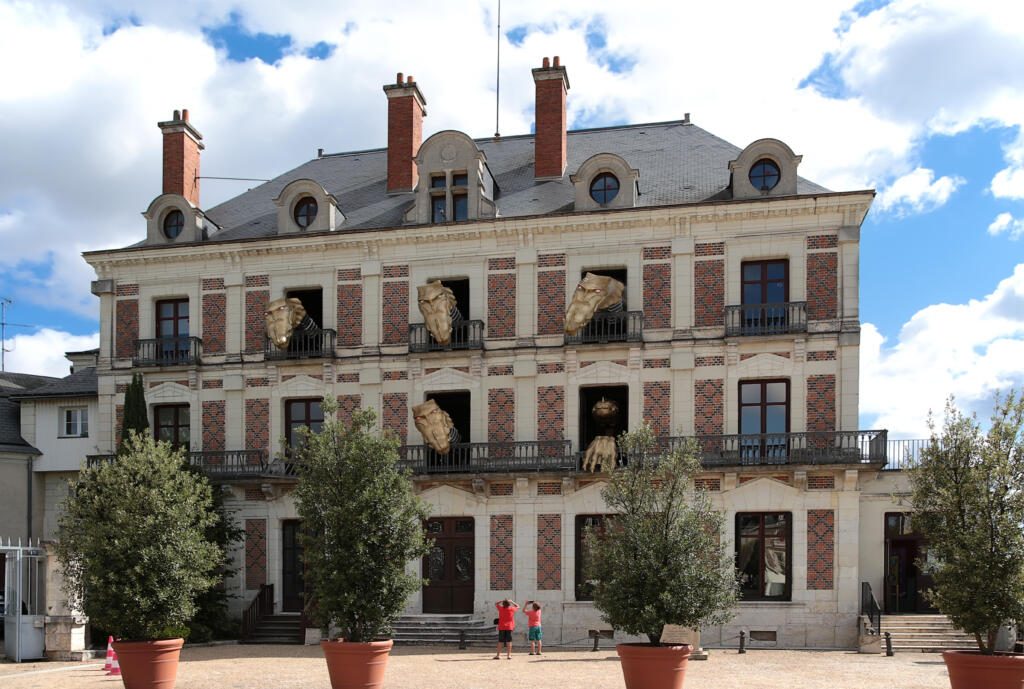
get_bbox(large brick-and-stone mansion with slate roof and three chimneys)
[86,58,902,648]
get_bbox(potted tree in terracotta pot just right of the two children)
[586,424,736,689]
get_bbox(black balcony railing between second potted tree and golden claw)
[398,440,577,475]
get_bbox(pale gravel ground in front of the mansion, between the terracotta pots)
[0,646,949,689]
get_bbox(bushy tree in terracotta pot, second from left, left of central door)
[295,396,428,689]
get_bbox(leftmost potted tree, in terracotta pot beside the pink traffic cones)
[54,433,224,689]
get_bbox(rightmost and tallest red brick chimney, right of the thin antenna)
[534,55,569,179]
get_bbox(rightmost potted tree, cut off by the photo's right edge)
[909,391,1024,689]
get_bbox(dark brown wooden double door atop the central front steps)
[423,517,474,613]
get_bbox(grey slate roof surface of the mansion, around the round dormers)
[184,121,828,246]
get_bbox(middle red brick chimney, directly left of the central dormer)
[384,72,427,193]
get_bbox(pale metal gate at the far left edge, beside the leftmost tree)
[0,539,46,662]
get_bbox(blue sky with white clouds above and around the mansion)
[0,0,1024,435]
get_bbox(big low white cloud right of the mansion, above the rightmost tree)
[860,263,1024,437]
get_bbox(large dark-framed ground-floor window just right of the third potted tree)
[736,512,793,601]
